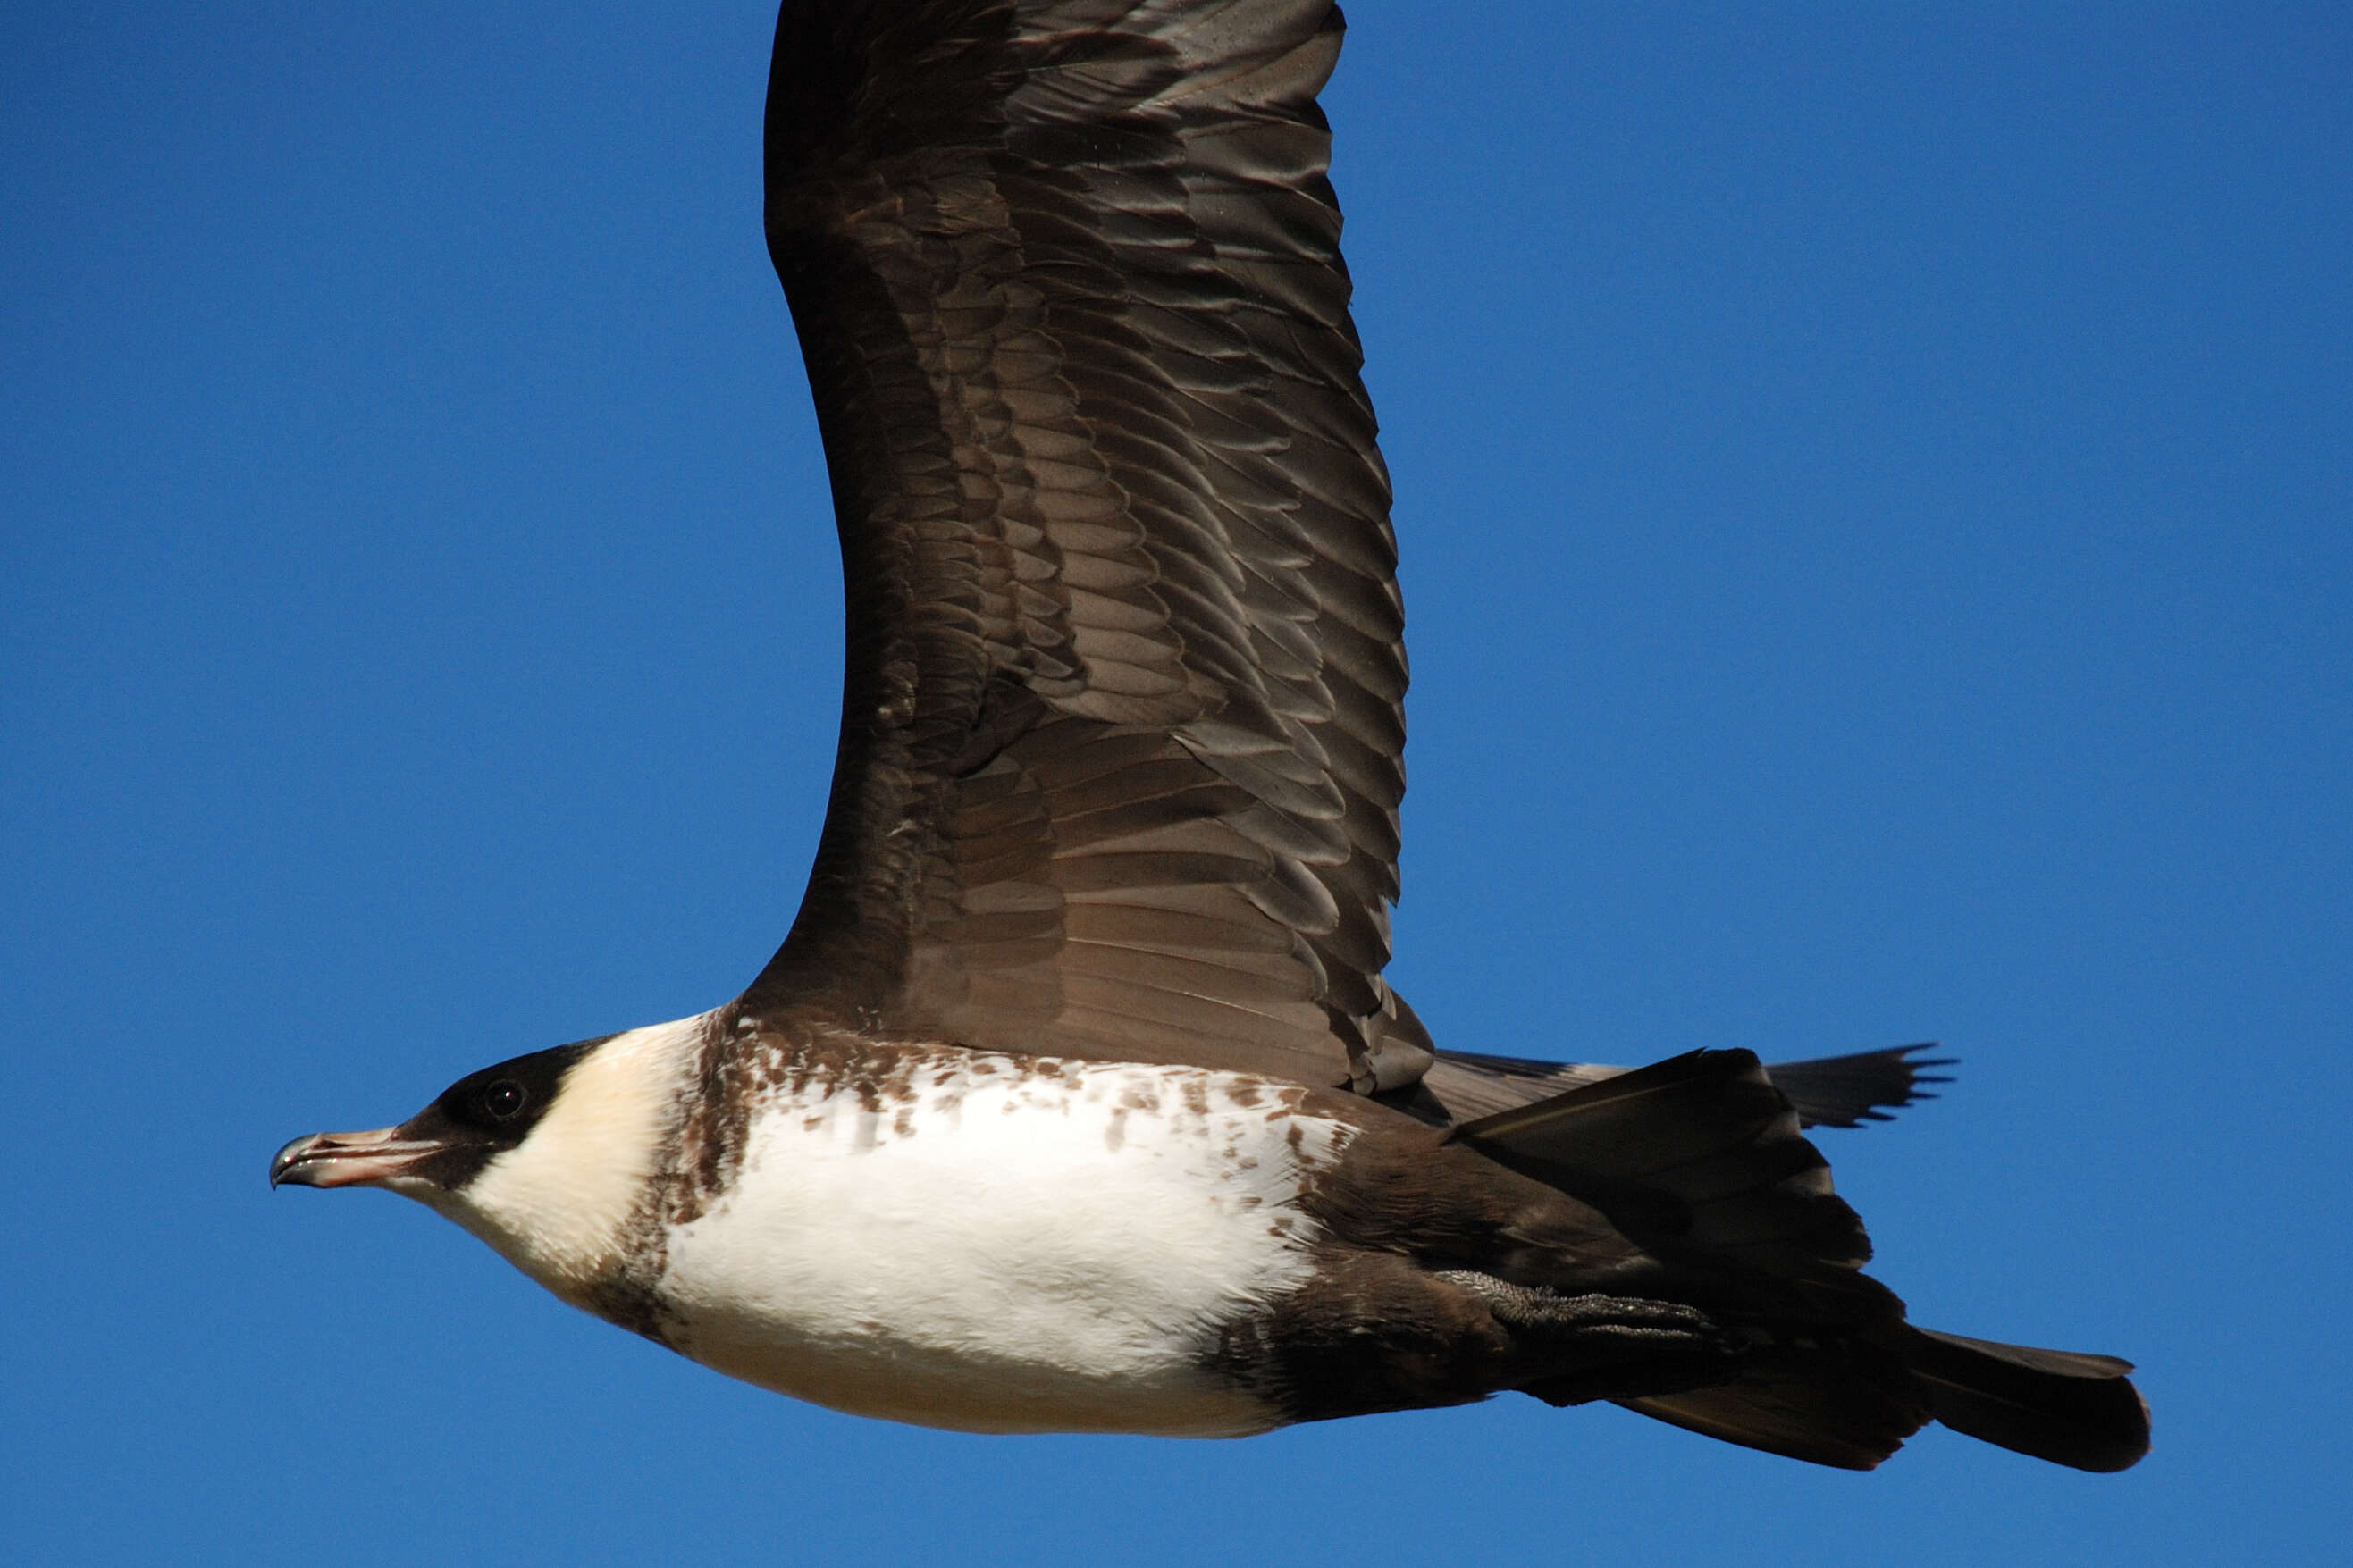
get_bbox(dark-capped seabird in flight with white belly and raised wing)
[271,0,2148,1469]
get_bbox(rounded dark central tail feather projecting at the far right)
[1903,1329,2148,1469]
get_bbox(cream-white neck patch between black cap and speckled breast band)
[423,1013,709,1307]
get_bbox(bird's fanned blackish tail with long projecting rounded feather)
[1454,1051,2148,1469]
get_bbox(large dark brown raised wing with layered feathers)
[744,0,1428,1088]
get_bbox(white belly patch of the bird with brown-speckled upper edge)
[661,1053,1350,1437]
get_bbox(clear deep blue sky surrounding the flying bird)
[0,0,2353,1568]
